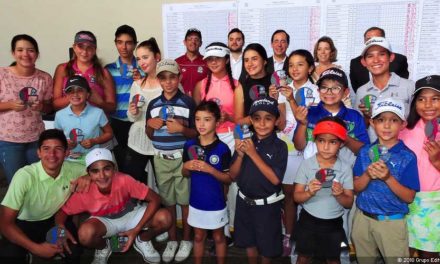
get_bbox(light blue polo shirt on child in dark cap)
[54,103,108,153]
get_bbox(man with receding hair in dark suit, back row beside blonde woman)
[266,29,290,74]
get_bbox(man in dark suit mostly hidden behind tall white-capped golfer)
[350,27,409,92]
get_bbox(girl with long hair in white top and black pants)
[123,38,162,184]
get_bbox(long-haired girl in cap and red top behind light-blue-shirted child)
[53,31,116,113]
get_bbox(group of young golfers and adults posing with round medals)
[0,25,440,263]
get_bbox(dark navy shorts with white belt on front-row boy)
[234,195,283,258]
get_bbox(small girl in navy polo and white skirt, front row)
[182,100,231,263]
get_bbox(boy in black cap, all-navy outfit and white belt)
[230,98,287,263]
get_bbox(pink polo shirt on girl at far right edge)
[399,119,440,192]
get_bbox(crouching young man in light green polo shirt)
[0,129,85,263]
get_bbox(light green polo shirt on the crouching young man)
[1,161,86,221]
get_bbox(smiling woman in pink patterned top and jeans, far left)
[0,35,53,182]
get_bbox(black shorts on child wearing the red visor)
[295,209,345,259]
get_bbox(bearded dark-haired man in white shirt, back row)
[228,28,246,80]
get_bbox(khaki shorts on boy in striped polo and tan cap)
[154,155,190,206]
